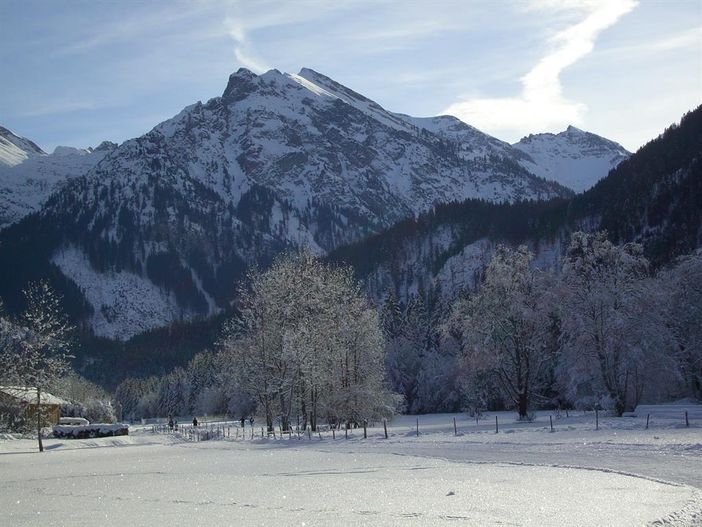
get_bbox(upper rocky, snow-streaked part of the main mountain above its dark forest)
[148,69,564,219]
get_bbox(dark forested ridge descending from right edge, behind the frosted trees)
[329,106,702,304]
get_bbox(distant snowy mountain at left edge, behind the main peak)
[0,131,117,229]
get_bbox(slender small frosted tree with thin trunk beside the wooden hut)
[1,281,73,452]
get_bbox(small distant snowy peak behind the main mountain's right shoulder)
[512,126,631,192]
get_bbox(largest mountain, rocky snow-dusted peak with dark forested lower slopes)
[0,69,571,339]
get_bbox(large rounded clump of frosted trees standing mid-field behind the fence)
[220,252,396,429]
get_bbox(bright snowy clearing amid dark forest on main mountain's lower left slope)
[52,247,195,340]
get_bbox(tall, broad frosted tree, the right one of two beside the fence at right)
[559,232,675,415]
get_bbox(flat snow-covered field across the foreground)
[0,412,702,525]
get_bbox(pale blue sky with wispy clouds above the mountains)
[0,0,702,152]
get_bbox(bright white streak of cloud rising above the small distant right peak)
[443,0,637,141]
